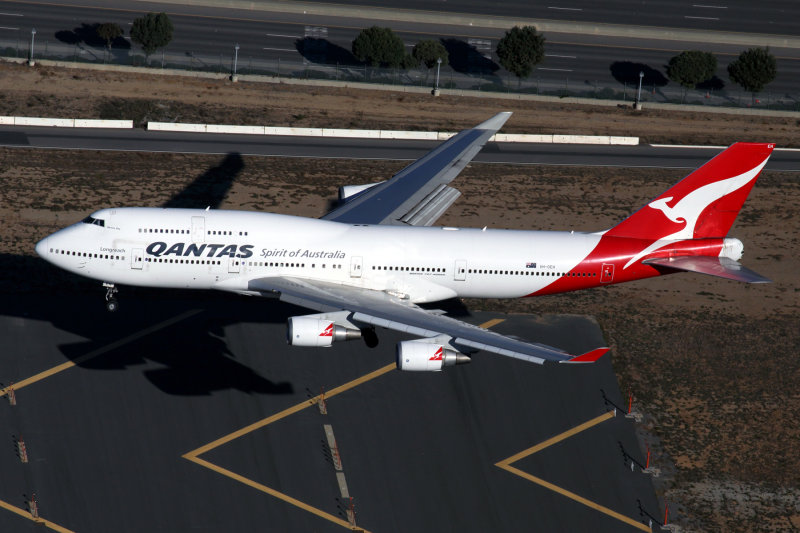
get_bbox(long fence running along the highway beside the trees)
[6,38,800,111]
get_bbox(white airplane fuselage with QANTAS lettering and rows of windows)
[37,208,601,303]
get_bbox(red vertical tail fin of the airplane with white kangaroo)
[606,143,775,240]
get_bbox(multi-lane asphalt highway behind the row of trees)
[0,2,800,98]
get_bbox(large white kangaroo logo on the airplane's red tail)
[622,159,767,270]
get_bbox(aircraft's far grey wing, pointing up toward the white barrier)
[322,112,511,226]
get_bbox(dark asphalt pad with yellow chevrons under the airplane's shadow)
[0,286,660,533]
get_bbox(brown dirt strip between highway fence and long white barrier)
[0,63,800,147]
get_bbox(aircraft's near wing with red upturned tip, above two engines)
[249,277,608,364]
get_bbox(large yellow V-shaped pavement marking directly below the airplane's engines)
[183,318,505,532]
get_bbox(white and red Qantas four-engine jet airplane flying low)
[36,112,774,371]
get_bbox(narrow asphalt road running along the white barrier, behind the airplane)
[0,126,800,170]
